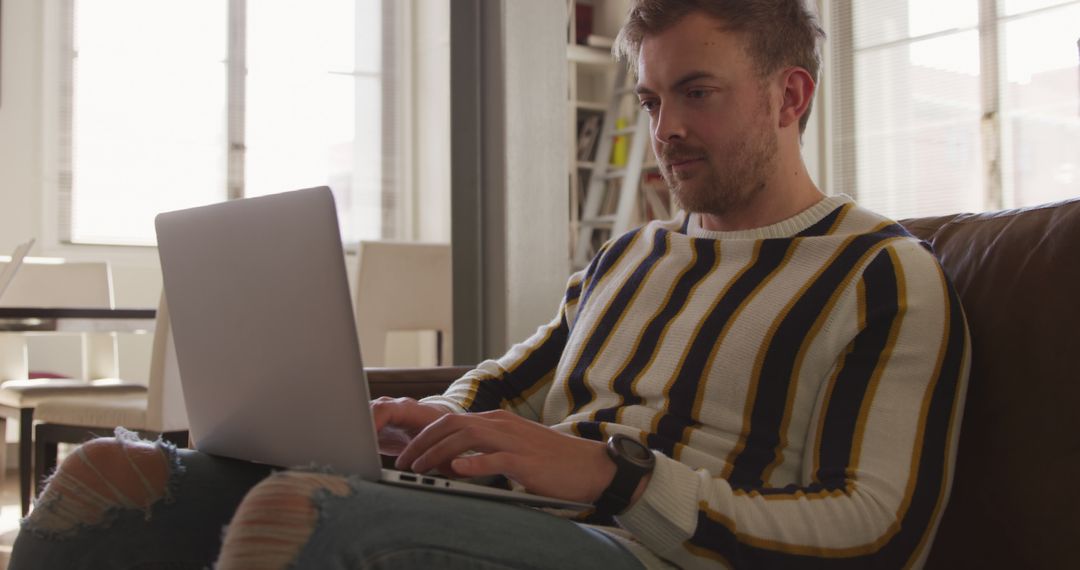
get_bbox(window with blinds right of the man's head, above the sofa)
[824,0,1080,218]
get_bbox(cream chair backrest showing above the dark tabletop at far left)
[0,260,112,309]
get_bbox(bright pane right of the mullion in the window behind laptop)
[244,0,383,242]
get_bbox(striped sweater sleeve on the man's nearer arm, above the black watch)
[617,240,970,569]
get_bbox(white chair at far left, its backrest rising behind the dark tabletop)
[0,260,146,514]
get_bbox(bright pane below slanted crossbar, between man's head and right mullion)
[854,31,984,218]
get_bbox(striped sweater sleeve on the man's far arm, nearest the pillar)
[421,264,598,421]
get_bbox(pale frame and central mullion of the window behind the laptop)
[41,0,406,253]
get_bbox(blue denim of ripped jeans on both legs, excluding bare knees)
[9,450,642,570]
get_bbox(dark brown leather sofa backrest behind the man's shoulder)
[902,200,1080,568]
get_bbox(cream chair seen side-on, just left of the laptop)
[33,296,188,494]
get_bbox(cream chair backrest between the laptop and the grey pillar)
[353,242,454,366]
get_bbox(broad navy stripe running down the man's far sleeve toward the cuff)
[467,314,569,411]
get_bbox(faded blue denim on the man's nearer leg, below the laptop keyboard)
[295,480,642,570]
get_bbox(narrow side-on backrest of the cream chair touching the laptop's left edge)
[146,293,188,432]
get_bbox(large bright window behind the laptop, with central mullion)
[56,0,404,245]
